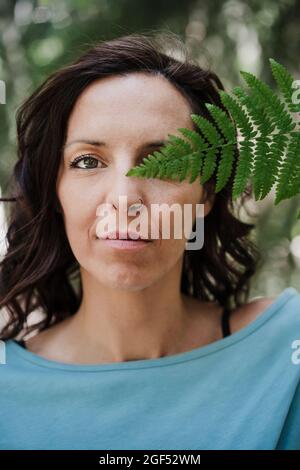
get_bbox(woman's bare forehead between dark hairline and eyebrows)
[68,75,193,140]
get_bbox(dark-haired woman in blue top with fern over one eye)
[0,31,300,449]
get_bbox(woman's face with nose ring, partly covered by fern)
[57,72,211,290]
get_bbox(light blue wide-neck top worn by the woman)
[0,287,300,450]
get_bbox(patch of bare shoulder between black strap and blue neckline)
[230,297,276,333]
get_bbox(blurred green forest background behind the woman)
[0,0,300,297]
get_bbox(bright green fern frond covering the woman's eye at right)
[127,59,300,218]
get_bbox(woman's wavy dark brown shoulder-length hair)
[0,33,260,339]
